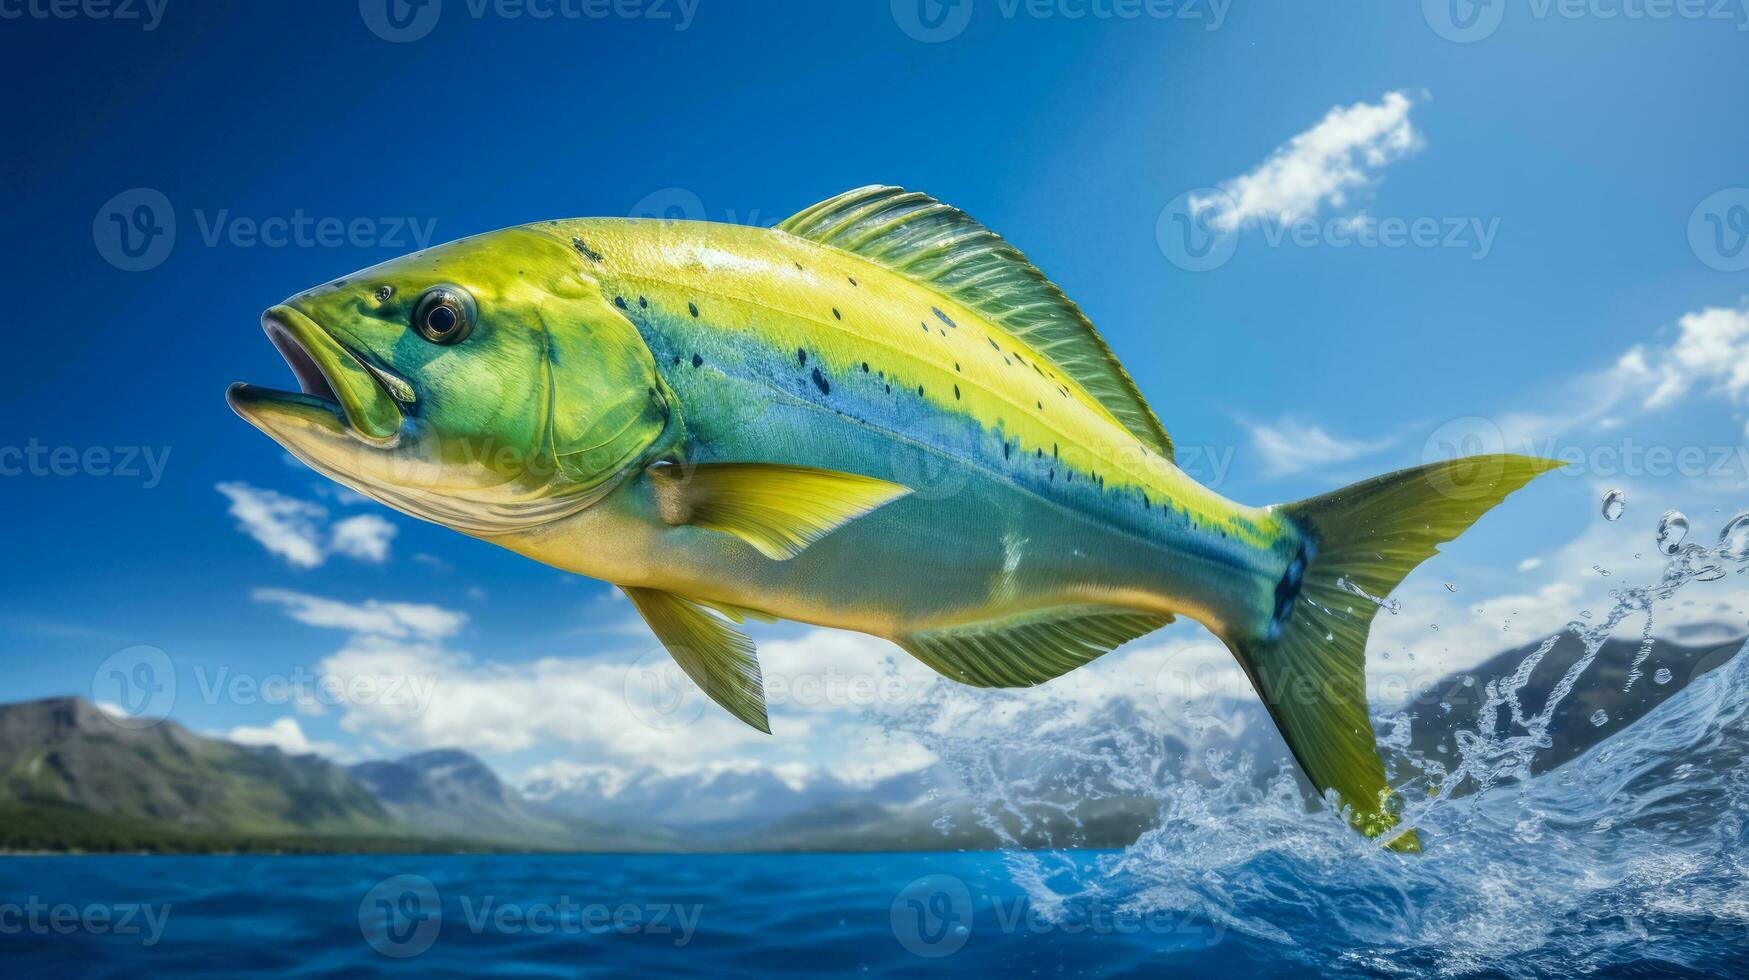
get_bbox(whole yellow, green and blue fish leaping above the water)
[229,187,1560,849]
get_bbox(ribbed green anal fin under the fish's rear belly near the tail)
[897,606,1172,688]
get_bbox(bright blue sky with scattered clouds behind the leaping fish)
[0,0,1749,787]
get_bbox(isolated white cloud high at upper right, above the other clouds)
[1191,91,1425,231]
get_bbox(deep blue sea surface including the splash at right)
[10,515,1749,980]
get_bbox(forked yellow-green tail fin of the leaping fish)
[1230,455,1562,851]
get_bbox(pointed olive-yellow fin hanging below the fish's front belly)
[621,586,771,735]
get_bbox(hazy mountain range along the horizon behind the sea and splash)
[0,639,1740,851]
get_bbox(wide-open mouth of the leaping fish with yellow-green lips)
[226,305,402,448]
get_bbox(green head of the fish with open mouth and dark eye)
[227,228,670,534]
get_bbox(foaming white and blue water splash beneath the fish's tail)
[902,513,1749,977]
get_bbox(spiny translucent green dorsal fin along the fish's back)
[778,184,1172,459]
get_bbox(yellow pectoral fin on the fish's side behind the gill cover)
[649,462,911,562]
